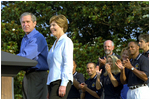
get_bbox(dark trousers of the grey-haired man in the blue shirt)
[22,71,48,99]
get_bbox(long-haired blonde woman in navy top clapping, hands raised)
[96,55,123,99]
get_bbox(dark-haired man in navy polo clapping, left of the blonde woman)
[80,62,102,99]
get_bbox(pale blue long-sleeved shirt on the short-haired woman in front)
[47,34,73,86]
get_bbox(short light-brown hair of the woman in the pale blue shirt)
[49,15,68,33]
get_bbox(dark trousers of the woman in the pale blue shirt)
[48,80,72,99]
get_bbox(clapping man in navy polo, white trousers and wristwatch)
[117,41,149,99]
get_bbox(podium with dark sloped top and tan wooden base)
[1,51,37,99]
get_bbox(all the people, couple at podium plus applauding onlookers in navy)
[17,12,149,99]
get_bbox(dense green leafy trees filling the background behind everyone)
[1,1,149,99]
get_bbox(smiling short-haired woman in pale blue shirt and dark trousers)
[47,15,73,99]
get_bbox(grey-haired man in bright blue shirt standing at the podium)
[17,12,48,99]
